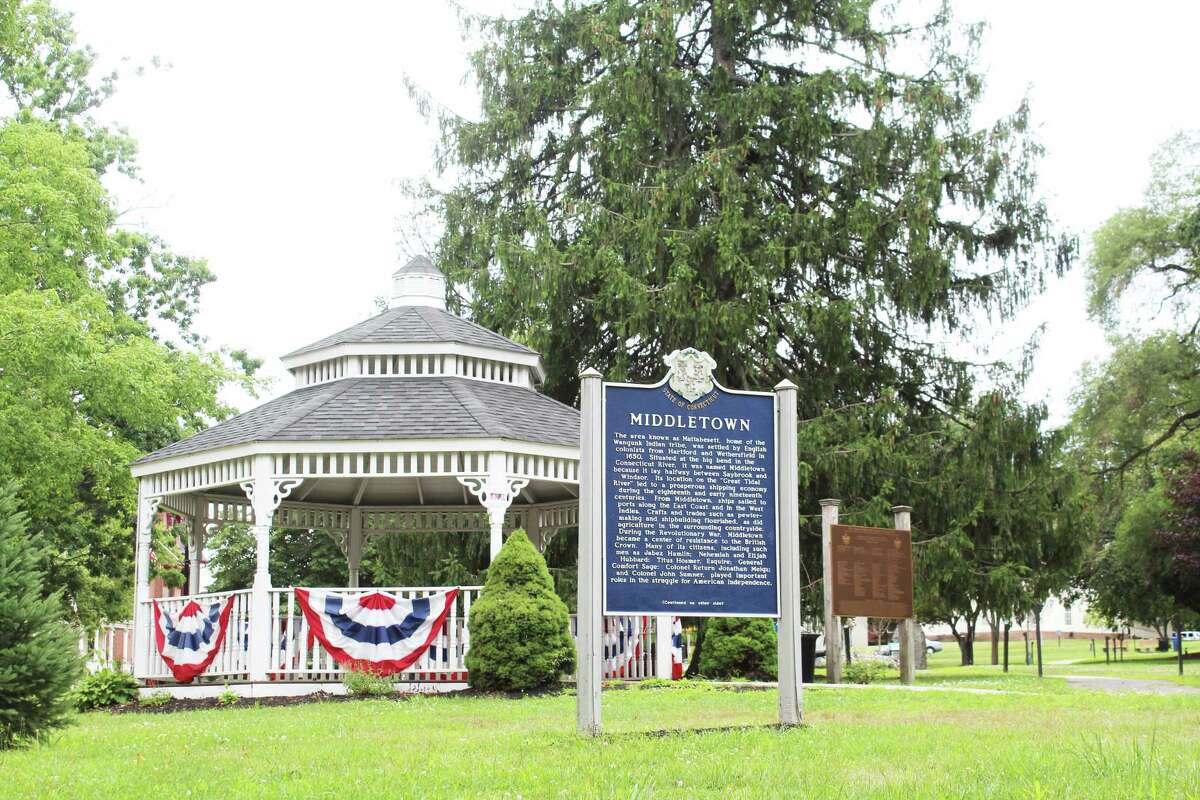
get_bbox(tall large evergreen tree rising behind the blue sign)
[414,0,1069,407]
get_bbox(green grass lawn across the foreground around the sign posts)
[0,678,1200,799]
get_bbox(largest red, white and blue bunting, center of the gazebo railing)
[295,589,458,675]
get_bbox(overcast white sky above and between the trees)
[59,0,1200,420]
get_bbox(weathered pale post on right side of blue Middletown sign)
[775,379,804,724]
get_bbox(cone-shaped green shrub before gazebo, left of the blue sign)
[467,530,575,692]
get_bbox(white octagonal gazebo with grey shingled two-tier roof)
[123,258,654,685]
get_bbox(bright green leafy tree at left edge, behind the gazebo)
[0,0,254,624]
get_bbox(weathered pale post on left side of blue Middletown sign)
[575,368,604,736]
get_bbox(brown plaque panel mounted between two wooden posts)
[829,525,912,619]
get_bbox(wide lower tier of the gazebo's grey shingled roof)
[134,375,580,464]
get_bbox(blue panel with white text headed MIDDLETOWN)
[604,381,779,616]
